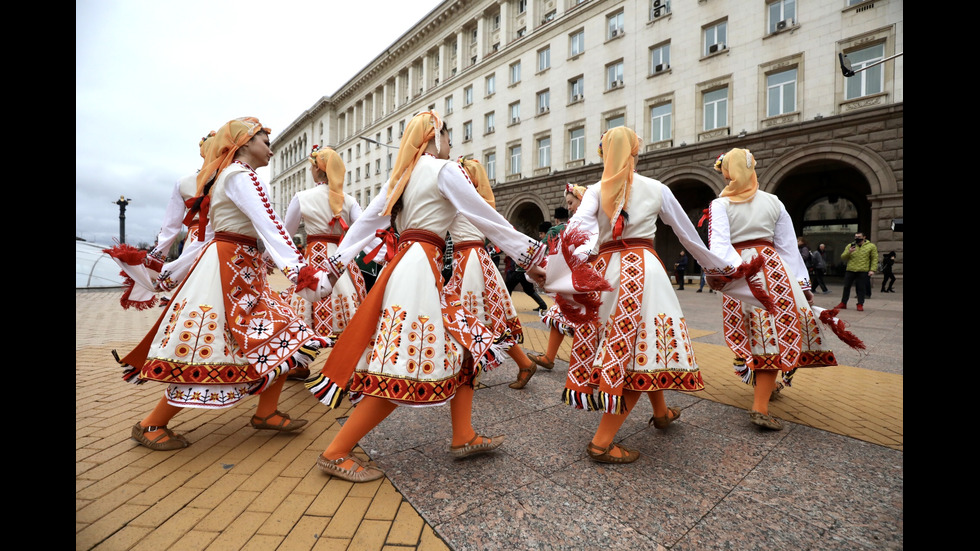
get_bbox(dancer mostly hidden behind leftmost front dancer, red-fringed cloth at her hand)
[104,130,215,310]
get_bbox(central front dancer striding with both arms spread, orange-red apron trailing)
[306,112,545,482]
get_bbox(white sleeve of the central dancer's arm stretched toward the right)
[438,164,547,270]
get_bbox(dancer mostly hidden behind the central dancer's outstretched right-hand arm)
[445,158,534,388]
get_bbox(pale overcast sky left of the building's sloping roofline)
[75,0,441,245]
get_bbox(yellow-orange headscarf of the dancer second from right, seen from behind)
[599,126,640,227]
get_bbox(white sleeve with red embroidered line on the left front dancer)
[225,173,306,283]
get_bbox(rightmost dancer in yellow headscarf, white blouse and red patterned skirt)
[708,148,863,430]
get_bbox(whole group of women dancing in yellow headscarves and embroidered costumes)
[107,112,861,482]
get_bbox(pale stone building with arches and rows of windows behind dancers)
[271,0,904,274]
